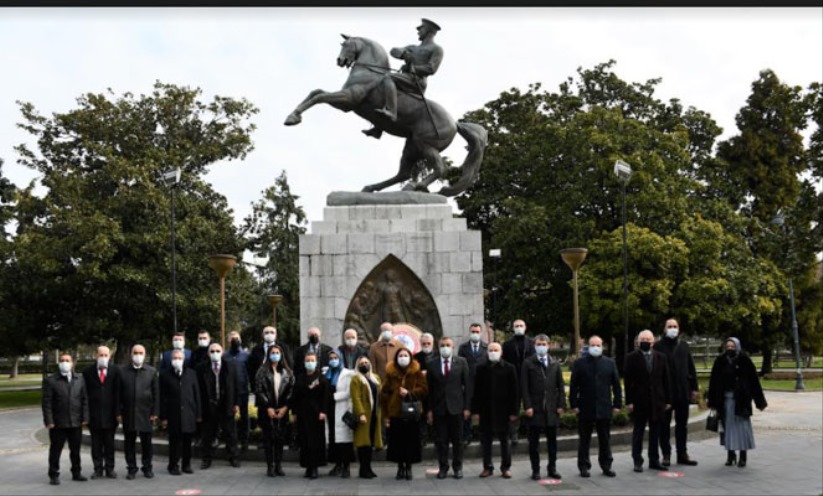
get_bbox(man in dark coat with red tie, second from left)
[83,346,120,479]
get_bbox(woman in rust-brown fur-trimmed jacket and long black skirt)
[380,348,429,480]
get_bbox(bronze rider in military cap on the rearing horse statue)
[363,19,443,139]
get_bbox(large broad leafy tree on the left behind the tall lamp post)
[15,82,257,356]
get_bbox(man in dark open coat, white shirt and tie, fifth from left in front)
[197,343,240,470]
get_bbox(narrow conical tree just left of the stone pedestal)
[242,171,306,345]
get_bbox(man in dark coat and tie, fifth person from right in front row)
[520,334,566,480]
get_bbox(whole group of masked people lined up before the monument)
[43,319,766,484]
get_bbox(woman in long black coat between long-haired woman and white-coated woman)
[289,353,331,479]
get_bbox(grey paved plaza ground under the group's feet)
[0,392,823,496]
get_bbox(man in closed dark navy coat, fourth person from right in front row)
[569,335,622,477]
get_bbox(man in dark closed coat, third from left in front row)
[118,344,160,480]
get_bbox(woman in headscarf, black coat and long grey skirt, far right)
[708,338,767,467]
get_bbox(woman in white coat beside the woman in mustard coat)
[326,351,357,479]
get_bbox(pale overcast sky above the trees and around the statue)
[0,7,823,232]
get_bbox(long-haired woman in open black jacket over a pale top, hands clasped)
[254,345,294,477]
